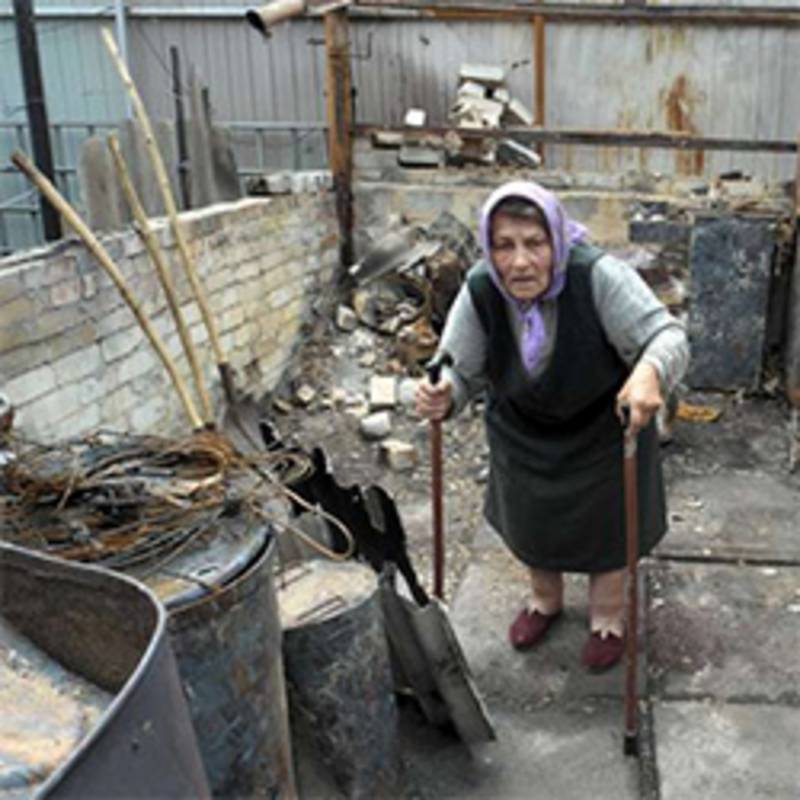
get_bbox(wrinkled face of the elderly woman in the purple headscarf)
[491,212,553,300]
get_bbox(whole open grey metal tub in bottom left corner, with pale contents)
[0,543,210,800]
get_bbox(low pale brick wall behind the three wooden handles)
[0,192,338,440]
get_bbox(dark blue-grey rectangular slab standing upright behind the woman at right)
[686,217,775,390]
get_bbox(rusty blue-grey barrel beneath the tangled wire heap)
[156,518,296,800]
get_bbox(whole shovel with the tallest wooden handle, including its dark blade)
[102,28,261,452]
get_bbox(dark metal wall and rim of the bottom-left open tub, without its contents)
[0,543,210,800]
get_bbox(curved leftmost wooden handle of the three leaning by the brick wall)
[11,150,203,428]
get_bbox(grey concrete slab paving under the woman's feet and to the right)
[396,397,800,800]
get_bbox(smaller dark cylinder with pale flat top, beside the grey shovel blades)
[278,559,402,800]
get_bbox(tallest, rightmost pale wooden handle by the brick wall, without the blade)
[102,28,234,402]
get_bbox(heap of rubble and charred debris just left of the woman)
[272,212,479,471]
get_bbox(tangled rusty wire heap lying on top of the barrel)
[0,431,304,573]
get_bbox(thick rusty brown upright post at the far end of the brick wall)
[325,8,355,267]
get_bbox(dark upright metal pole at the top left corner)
[14,0,61,242]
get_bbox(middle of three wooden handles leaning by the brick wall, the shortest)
[108,134,214,423]
